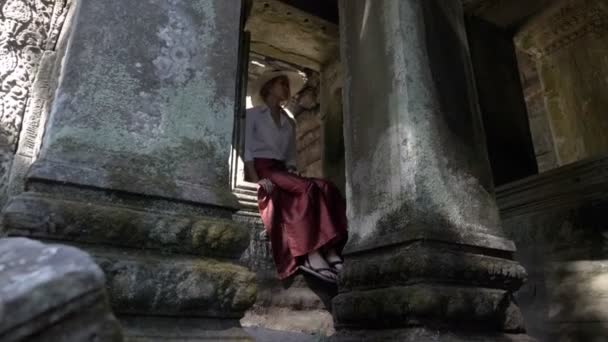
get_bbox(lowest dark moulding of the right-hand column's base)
[333,285,524,333]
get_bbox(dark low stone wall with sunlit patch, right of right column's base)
[496,158,608,342]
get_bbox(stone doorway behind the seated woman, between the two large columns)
[231,0,345,336]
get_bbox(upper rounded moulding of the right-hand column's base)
[340,242,527,292]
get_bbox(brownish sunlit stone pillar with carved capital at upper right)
[515,0,608,166]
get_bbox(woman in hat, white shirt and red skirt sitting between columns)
[245,71,347,283]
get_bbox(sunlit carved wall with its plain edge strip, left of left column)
[0,0,72,202]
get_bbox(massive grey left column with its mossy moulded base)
[3,0,256,339]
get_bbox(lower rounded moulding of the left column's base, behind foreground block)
[87,247,257,319]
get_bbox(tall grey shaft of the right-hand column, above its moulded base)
[342,1,513,251]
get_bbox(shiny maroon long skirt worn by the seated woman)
[254,158,348,279]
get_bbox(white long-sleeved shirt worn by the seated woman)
[244,106,296,167]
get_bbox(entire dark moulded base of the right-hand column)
[333,241,526,341]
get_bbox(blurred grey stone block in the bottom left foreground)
[0,238,123,342]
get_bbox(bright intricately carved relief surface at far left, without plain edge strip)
[0,0,71,199]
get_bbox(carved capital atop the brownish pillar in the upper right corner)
[515,0,608,58]
